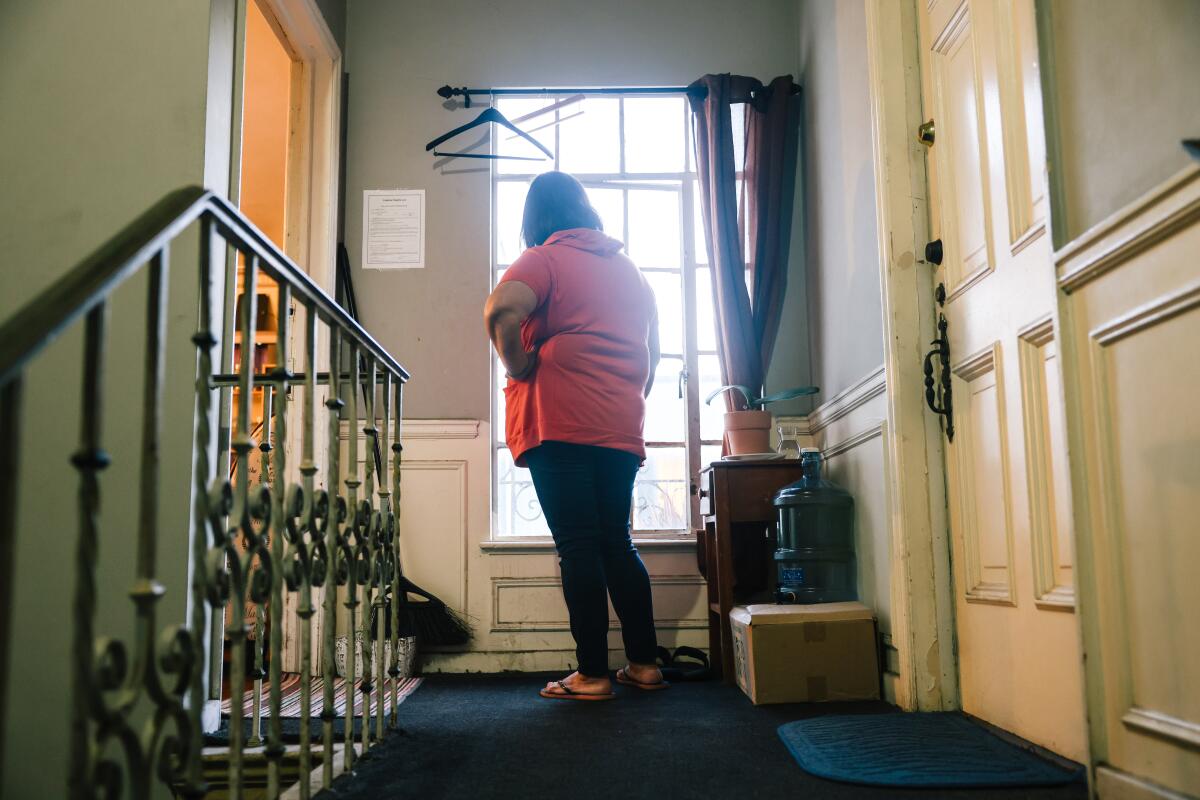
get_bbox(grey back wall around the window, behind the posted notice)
[346,0,803,420]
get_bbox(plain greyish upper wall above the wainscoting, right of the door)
[1038,0,1200,246]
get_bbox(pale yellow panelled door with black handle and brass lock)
[914,0,1087,762]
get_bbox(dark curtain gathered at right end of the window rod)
[688,74,800,409]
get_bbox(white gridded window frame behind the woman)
[488,92,742,545]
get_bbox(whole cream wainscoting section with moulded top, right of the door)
[1057,176,1200,798]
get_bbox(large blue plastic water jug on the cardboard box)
[774,447,858,603]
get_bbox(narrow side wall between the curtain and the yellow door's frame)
[797,0,896,699]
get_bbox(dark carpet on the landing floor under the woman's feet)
[318,675,1087,800]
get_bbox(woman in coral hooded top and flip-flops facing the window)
[484,172,666,700]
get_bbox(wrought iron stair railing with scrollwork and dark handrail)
[0,187,409,798]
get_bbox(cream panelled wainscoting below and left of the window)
[348,420,708,672]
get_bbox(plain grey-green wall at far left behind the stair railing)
[0,0,232,798]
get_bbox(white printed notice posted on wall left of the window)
[362,188,425,270]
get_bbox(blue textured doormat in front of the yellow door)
[779,712,1085,789]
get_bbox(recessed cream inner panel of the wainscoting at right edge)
[1093,307,1200,744]
